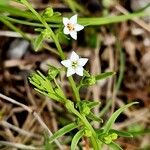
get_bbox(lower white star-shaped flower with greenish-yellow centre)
[61,51,88,77]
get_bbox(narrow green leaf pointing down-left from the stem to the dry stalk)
[49,123,78,143]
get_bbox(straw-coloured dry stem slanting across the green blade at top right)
[115,4,150,32]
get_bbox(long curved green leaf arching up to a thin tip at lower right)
[103,102,138,133]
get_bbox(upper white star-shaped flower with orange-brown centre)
[63,15,84,40]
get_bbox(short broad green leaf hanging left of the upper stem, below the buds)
[33,33,44,52]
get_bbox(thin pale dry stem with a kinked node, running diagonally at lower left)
[0,93,62,150]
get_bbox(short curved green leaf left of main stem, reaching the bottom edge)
[71,130,84,150]
